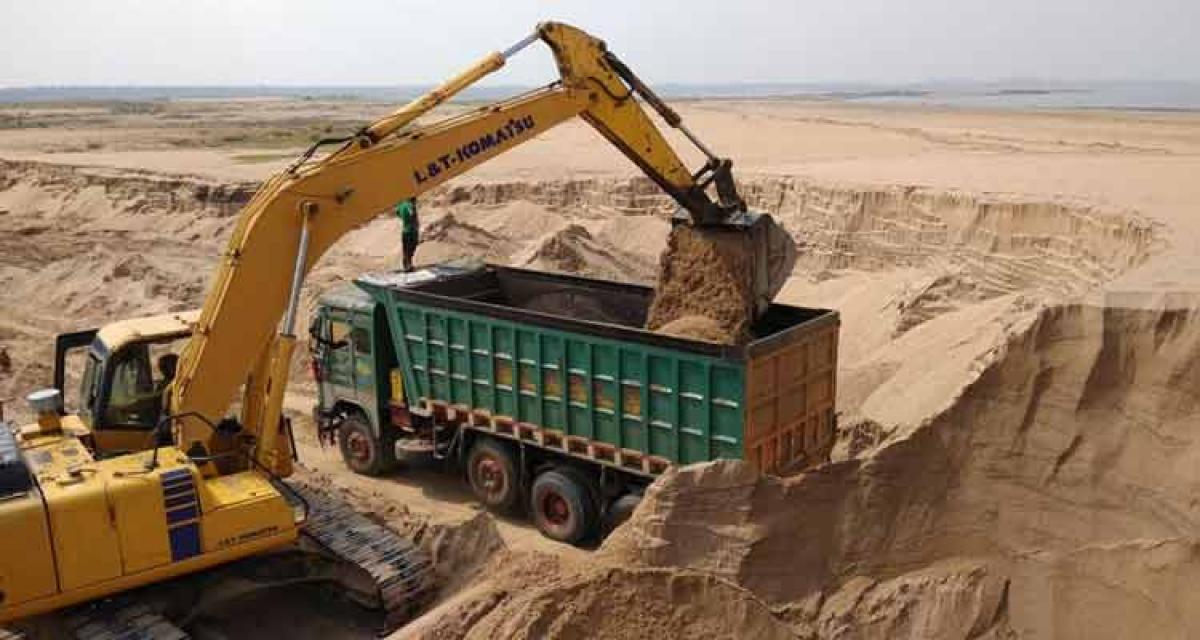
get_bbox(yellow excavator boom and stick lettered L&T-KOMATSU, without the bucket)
[170,23,745,468]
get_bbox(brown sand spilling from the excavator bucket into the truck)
[646,225,755,343]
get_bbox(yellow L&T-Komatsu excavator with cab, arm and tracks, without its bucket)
[0,23,786,639]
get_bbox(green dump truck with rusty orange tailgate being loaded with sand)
[310,264,840,543]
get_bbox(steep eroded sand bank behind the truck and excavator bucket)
[426,175,1160,294]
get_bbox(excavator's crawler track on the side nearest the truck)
[288,483,437,633]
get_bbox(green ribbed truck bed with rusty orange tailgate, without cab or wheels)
[356,265,839,475]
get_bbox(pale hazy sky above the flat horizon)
[0,0,1200,86]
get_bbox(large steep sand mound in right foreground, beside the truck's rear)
[602,300,1200,638]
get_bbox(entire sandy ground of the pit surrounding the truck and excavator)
[0,101,1200,638]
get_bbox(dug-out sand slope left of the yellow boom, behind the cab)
[0,161,254,417]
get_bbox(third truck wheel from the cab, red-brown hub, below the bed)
[529,467,599,544]
